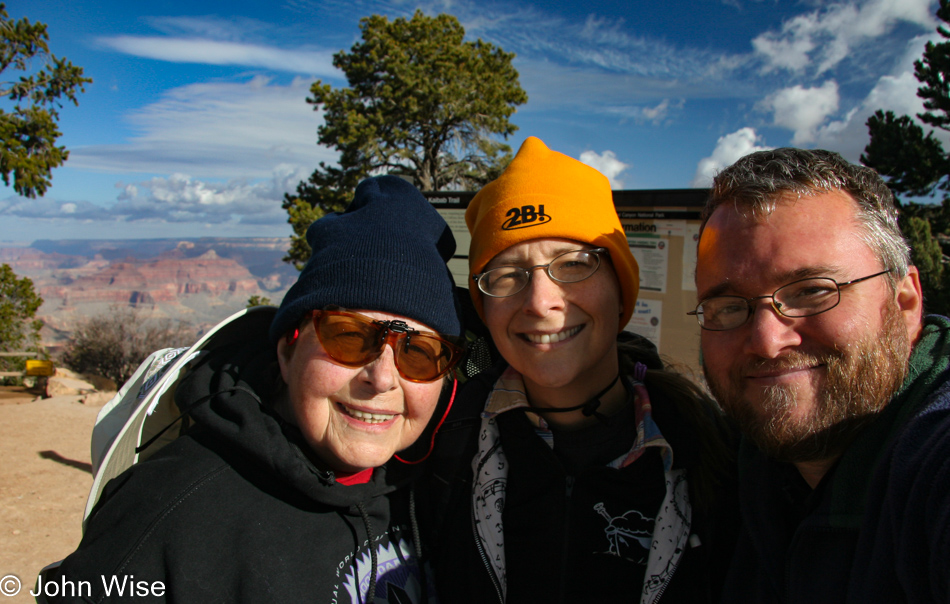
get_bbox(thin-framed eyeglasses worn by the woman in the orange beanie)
[472,247,607,298]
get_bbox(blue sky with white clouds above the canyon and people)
[0,0,947,245]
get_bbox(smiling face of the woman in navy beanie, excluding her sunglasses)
[277,310,443,472]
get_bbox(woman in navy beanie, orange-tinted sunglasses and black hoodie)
[47,176,461,604]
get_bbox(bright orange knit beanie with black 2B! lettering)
[465,136,640,329]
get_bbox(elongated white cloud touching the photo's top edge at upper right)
[752,0,936,74]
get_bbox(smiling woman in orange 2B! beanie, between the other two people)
[433,138,735,603]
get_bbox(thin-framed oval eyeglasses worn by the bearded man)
[686,269,893,331]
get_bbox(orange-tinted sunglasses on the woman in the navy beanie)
[311,308,462,382]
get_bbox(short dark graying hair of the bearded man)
[700,147,911,285]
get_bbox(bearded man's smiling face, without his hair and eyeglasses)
[696,191,921,462]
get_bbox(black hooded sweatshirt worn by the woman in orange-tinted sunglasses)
[42,315,428,604]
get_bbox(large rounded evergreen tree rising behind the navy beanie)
[283,11,528,268]
